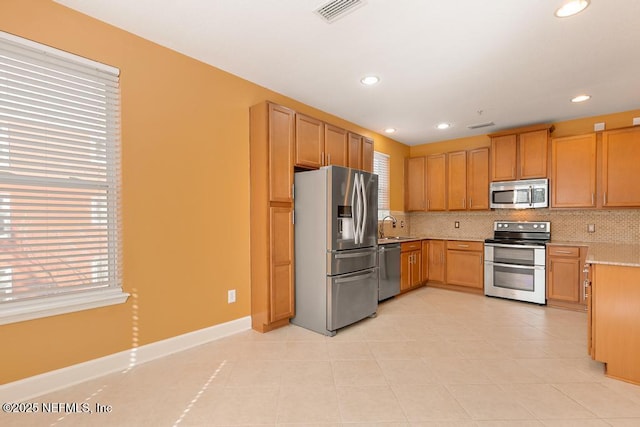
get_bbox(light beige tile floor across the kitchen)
[0,288,640,427]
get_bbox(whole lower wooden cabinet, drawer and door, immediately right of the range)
[547,245,587,311]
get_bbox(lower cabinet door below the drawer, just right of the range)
[547,257,580,303]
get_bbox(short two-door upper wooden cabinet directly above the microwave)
[489,125,552,181]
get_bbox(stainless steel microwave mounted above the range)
[489,179,549,209]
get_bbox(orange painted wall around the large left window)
[0,0,409,383]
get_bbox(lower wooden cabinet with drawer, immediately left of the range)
[447,240,484,289]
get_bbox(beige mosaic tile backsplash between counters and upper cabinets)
[400,209,640,243]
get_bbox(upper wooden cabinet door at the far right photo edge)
[602,128,640,207]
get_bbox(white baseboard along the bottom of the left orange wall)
[0,316,251,402]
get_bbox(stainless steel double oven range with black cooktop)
[484,221,551,304]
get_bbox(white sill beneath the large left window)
[0,288,129,325]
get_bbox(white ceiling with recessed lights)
[55,0,640,145]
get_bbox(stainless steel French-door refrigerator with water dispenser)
[292,166,378,336]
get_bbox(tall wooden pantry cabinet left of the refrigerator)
[250,102,296,332]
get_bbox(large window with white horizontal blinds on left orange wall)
[0,32,128,324]
